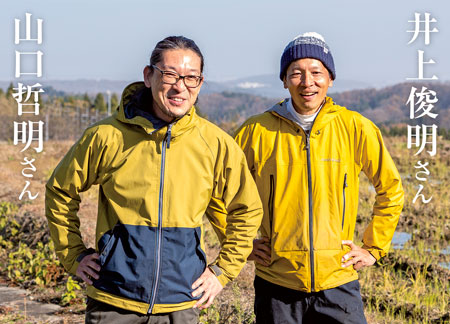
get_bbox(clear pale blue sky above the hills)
[0,0,450,84]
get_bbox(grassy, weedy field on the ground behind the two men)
[0,137,450,324]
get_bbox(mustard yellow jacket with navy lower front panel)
[46,83,262,314]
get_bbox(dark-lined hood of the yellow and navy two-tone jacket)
[114,82,197,137]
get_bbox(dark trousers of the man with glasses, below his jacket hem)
[85,298,200,324]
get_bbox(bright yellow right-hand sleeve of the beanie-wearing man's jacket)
[357,118,404,259]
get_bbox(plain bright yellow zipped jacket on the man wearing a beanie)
[236,98,403,292]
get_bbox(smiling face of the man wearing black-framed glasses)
[144,49,203,122]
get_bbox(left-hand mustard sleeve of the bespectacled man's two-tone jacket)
[45,129,104,274]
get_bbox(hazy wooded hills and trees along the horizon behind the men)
[0,83,450,139]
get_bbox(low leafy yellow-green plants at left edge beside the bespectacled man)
[0,202,88,305]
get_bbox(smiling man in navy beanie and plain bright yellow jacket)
[236,33,403,324]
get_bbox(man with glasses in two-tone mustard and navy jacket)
[46,36,262,324]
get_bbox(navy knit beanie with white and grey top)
[280,32,336,81]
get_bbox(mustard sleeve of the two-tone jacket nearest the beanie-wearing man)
[206,138,262,286]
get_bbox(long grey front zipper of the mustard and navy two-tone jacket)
[147,124,173,314]
